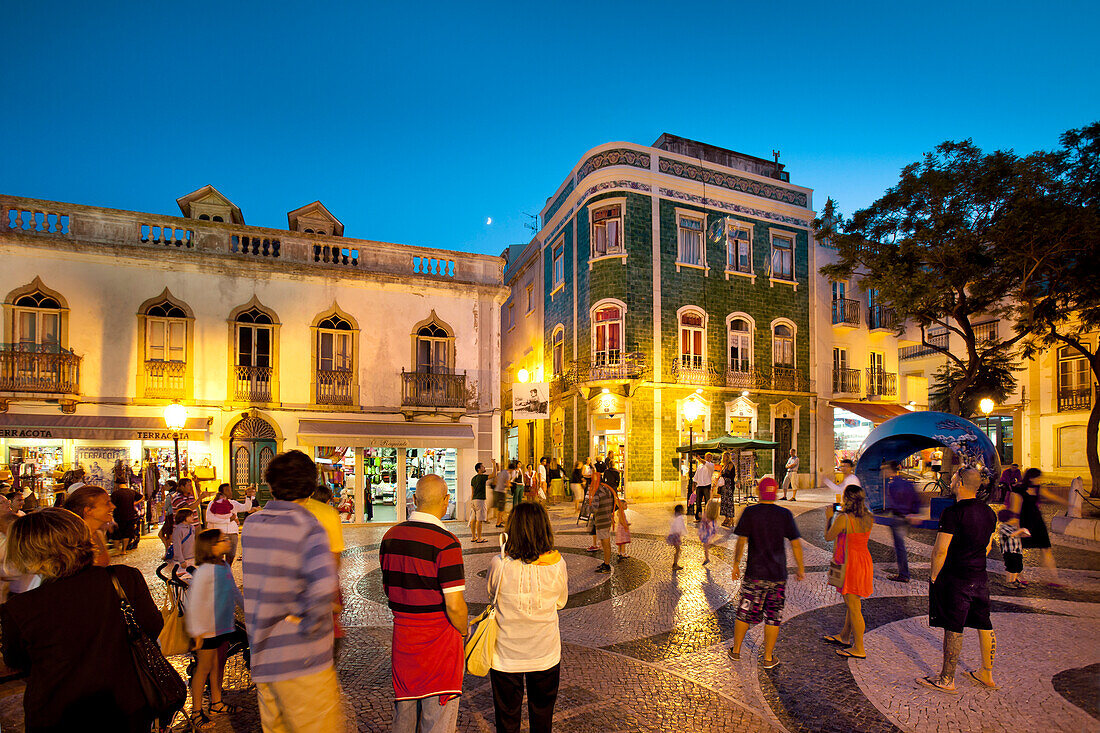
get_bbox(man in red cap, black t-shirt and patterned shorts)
[729,477,805,669]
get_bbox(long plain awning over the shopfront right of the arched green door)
[298,420,475,448]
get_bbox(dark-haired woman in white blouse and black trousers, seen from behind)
[488,502,569,733]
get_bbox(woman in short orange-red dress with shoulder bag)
[824,482,875,659]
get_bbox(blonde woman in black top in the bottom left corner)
[0,507,163,733]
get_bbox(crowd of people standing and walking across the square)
[0,442,1060,733]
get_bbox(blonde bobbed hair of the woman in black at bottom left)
[8,507,95,580]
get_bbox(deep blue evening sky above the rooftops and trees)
[0,0,1100,254]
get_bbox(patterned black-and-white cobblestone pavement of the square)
[0,492,1100,733]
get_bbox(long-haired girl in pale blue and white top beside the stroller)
[184,529,244,731]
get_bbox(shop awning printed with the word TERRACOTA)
[0,413,210,440]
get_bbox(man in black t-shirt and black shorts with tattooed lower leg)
[916,468,997,694]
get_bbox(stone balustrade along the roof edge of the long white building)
[0,196,504,286]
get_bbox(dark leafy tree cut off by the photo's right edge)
[999,122,1100,497]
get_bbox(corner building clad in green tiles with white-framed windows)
[502,134,814,499]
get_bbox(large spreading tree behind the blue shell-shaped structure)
[814,140,1029,415]
